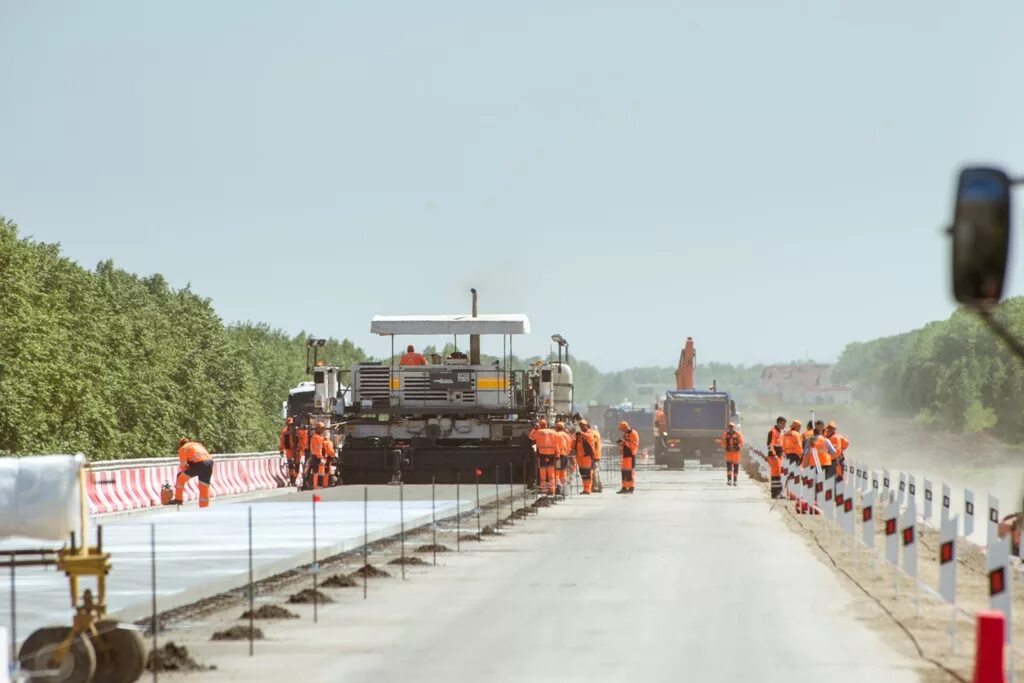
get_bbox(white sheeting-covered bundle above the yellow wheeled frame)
[0,454,85,541]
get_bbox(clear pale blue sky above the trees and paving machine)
[0,0,1024,371]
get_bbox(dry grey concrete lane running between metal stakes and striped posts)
[190,470,919,683]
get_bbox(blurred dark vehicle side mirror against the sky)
[949,167,1013,307]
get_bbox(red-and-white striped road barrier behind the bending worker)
[86,453,288,515]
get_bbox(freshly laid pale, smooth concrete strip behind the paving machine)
[0,484,495,641]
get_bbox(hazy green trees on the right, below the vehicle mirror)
[834,297,1024,442]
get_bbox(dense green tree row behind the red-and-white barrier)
[0,216,366,459]
